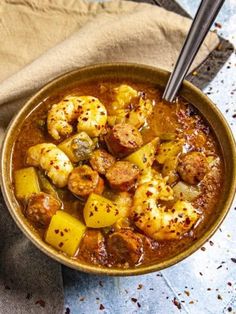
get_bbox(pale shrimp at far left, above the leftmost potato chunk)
[26,143,73,188]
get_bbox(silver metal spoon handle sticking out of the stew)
[162,0,224,102]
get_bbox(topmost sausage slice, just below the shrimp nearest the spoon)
[105,124,143,157]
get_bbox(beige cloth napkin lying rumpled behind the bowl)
[0,0,219,144]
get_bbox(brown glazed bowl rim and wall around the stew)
[1,63,236,276]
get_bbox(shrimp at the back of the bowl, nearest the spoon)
[108,85,153,129]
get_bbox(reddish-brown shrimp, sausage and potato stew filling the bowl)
[13,80,223,268]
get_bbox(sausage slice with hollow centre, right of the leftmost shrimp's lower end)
[68,165,104,197]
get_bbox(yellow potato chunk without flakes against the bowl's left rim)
[15,167,40,200]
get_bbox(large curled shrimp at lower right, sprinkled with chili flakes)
[131,168,200,240]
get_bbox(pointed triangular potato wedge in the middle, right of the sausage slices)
[125,138,159,170]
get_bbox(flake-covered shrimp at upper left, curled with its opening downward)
[47,95,107,140]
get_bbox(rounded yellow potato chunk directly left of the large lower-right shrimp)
[84,193,122,228]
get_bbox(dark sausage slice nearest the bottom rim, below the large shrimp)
[107,230,143,266]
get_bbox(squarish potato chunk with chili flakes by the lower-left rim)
[45,210,86,256]
